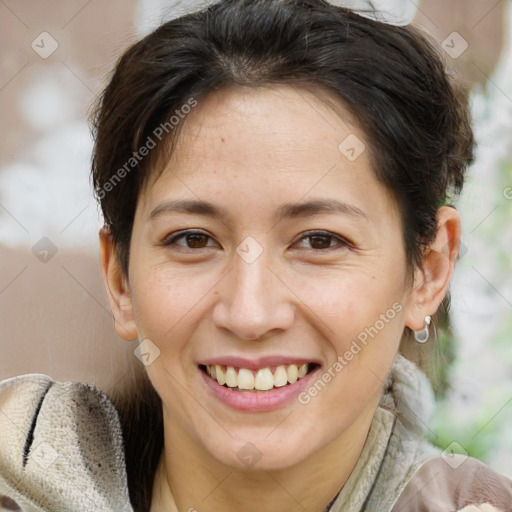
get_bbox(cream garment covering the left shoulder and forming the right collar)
[0,355,438,512]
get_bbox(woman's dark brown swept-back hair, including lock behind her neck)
[92,0,473,511]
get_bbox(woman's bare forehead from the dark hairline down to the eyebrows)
[141,86,400,223]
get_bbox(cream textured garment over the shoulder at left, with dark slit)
[0,374,130,511]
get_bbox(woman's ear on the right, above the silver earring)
[405,206,461,331]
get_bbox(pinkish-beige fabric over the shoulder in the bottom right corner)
[393,454,512,512]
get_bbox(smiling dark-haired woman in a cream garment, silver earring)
[0,0,512,512]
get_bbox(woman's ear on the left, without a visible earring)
[99,227,138,340]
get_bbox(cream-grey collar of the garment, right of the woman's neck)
[327,355,441,512]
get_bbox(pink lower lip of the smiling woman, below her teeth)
[199,367,320,412]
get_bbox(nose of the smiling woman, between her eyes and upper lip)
[213,248,295,340]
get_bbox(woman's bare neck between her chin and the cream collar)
[151,407,376,512]
